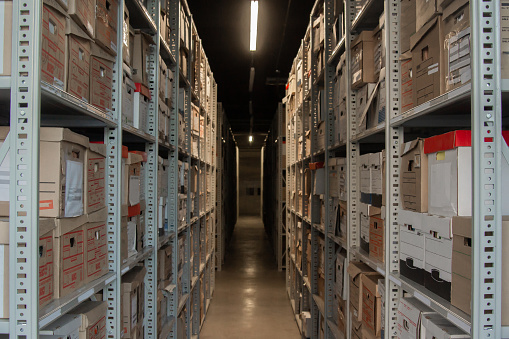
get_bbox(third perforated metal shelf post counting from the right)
[344,0,361,335]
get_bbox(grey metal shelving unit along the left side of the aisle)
[0,0,223,338]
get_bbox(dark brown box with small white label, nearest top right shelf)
[410,16,443,105]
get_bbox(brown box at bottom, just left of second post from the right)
[361,274,383,337]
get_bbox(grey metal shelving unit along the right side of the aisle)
[283,0,509,338]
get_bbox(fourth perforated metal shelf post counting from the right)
[320,0,338,339]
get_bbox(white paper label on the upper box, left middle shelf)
[65,160,84,217]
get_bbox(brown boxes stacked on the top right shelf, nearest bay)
[400,0,472,111]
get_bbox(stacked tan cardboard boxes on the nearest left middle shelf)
[0,127,108,318]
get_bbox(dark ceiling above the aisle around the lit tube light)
[188,0,314,133]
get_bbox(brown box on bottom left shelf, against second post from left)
[72,301,108,339]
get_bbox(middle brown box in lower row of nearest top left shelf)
[65,18,92,102]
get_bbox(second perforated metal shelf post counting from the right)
[380,0,404,337]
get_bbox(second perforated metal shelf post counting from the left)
[103,1,125,338]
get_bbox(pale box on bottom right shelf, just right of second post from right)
[397,298,435,339]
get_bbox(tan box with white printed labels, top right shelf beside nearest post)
[442,0,472,92]
